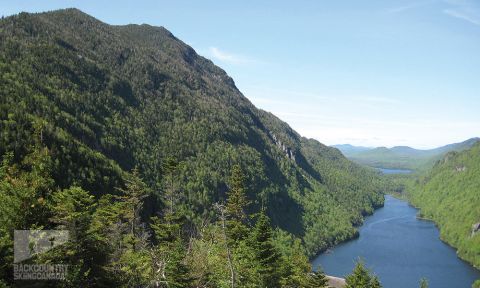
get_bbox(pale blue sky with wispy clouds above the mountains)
[0,0,480,148]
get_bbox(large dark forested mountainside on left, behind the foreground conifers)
[0,9,385,255]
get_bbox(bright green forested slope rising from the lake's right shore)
[407,143,480,267]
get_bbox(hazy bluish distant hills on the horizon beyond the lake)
[334,138,480,170]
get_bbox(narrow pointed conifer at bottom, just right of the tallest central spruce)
[250,211,281,287]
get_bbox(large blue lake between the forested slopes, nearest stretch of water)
[312,195,480,288]
